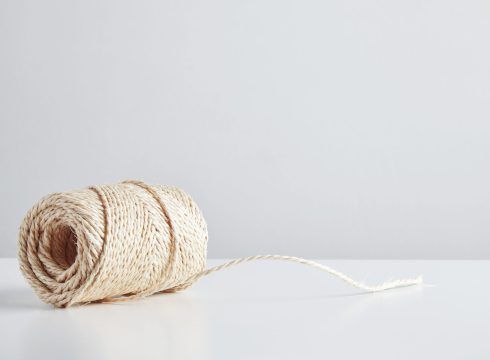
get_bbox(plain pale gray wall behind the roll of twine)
[0,0,490,258]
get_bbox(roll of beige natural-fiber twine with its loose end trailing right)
[19,181,422,307]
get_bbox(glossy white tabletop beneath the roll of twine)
[0,259,490,360]
